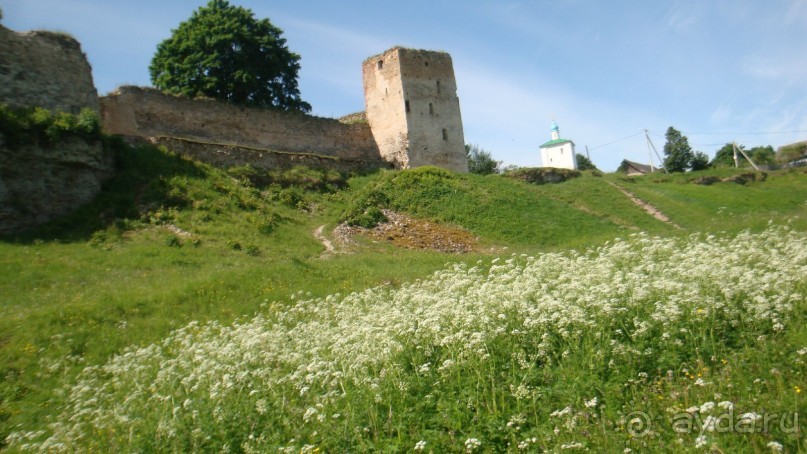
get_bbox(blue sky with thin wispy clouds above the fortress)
[0,0,807,171]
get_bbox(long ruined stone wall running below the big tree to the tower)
[101,87,386,167]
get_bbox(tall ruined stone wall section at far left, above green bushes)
[0,26,98,113]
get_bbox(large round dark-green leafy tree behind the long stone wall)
[149,0,311,112]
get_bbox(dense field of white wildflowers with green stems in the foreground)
[9,226,807,452]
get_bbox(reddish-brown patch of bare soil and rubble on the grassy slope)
[334,210,479,254]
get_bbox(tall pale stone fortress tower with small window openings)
[362,47,468,172]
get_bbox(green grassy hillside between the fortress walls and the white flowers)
[0,144,807,451]
